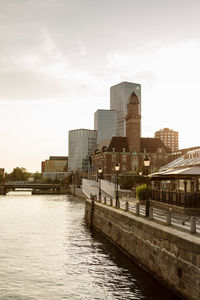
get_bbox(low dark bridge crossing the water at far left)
[0,181,61,195]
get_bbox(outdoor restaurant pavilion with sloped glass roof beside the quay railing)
[150,149,200,215]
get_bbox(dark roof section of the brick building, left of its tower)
[96,136,129,152]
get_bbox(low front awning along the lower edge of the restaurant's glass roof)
[149,167,200,180]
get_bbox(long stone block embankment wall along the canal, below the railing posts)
[85,199,200,300]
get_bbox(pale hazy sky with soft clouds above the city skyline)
[0,0,200,172]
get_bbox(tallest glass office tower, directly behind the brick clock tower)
[110,81,141,136]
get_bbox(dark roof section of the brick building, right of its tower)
[140,138,171,153]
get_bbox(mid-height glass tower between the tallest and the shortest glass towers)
[94,109,117,144]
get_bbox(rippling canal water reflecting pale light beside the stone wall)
[0,192,178,300]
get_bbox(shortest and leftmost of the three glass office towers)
[68,129,97,172]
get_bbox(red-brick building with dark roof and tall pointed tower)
[91,92,172,180]
